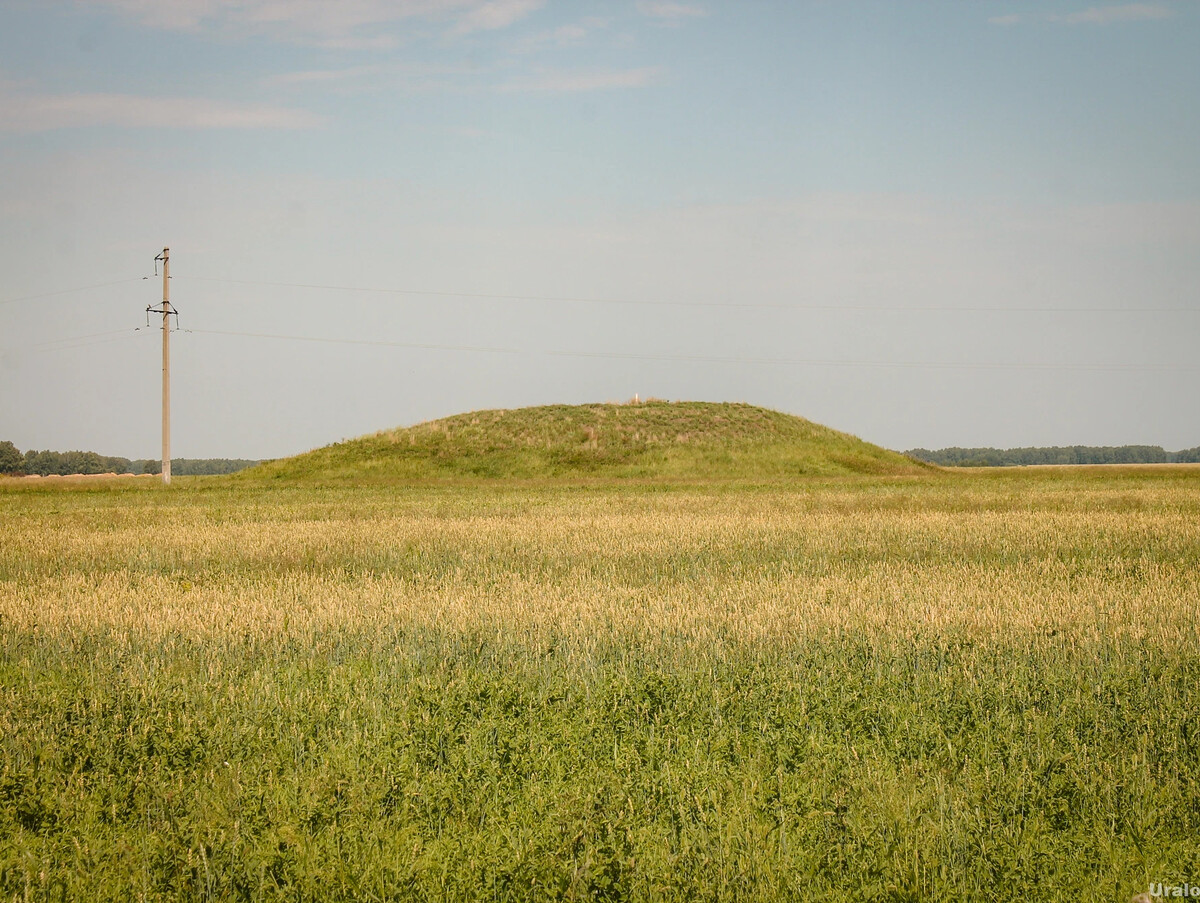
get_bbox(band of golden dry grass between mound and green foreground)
[0,478,1200,646]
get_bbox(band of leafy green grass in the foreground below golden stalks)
[0,632,1200,899]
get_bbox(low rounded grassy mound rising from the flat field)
[246,401,925,480]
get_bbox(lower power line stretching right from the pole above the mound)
[184,329,1200,372]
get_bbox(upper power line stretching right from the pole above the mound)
[176,276,1200,313]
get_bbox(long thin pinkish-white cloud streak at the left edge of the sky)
[0,89,324,133]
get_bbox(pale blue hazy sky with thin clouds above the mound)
[0,0,1200,458]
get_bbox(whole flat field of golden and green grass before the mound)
[0,466,1200,901]
